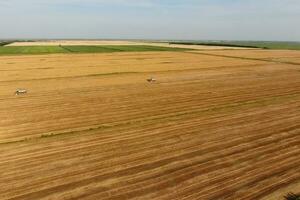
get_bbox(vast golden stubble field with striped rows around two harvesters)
[0,50,300,200]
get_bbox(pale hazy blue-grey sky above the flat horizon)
[0,0,300,41]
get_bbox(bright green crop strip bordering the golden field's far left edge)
[0,45,190,55]
